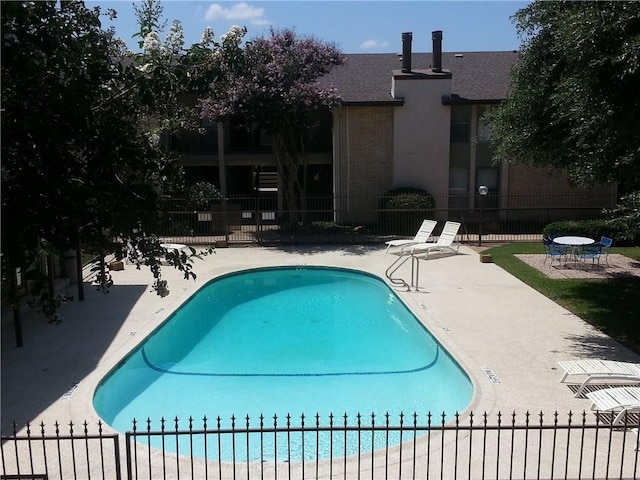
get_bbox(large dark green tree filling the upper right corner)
[490,0,640,192]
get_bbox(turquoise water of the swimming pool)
[94,267,473,459]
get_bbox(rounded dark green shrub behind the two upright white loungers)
[379,187,436,235]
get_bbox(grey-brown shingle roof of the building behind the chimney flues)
[322,51,518,103]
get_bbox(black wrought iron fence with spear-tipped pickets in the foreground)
[1,412,640,480]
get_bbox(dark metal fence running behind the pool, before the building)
[160,195,615,244]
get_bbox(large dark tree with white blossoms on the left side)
[1,1,215,340]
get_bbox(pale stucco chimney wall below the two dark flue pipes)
[392,71,451,208]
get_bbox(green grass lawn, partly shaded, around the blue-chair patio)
[483,243,640,354]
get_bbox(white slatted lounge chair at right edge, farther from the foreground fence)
[558,359,640,397]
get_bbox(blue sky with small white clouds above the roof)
[85,0,529,53]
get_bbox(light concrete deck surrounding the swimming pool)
[1,245,640,464]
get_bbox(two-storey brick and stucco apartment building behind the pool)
[174,31,617,222]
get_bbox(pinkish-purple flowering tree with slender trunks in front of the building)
[200,27,343,223]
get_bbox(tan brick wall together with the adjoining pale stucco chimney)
[334,71,451,222]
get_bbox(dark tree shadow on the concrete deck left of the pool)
[1,284,152,434]
